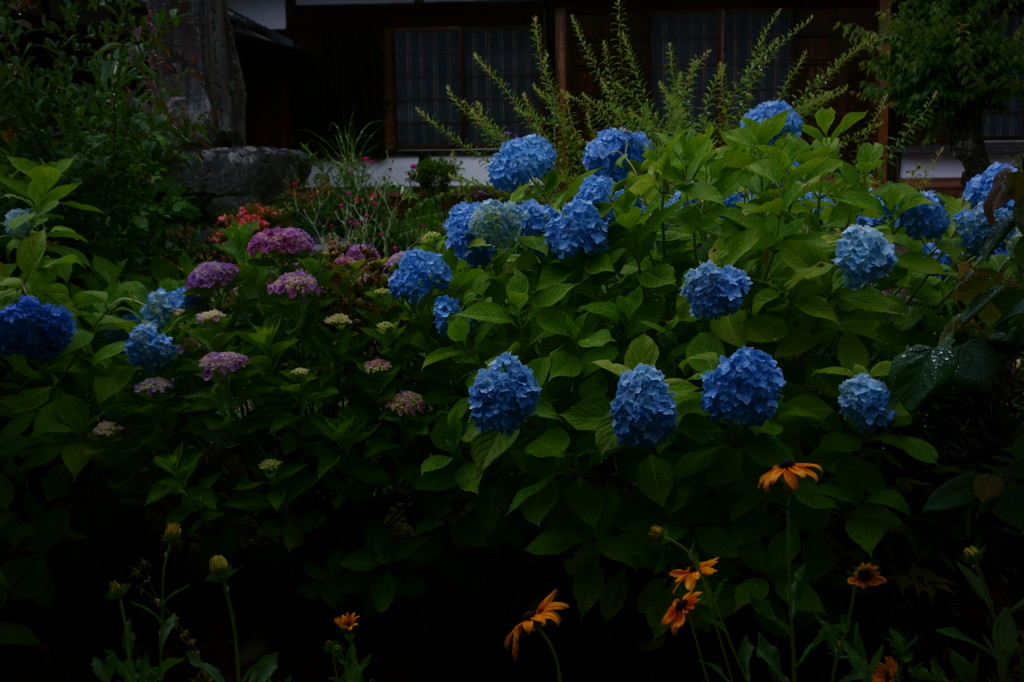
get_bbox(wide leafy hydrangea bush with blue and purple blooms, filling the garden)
[0,111,1022,677]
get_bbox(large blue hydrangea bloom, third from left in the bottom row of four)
[700,346,785,426]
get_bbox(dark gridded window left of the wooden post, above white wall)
[394,27,537,150]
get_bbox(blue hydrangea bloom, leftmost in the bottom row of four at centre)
[469,352,541,434]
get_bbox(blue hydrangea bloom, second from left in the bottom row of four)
[610,365,678,447]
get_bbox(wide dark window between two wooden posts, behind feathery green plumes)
[651,9,793,115]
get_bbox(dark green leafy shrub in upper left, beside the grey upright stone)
[0,0,200,258]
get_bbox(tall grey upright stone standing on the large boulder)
[144,0,246,146]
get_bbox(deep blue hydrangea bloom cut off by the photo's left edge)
[0,295,76,363]
